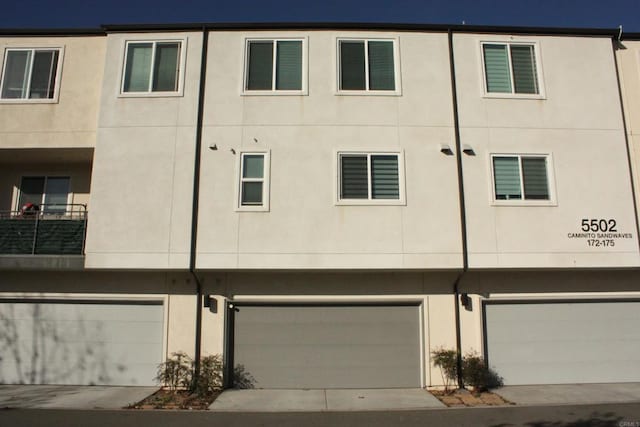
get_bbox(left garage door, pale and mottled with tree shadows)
[0,300,163,385]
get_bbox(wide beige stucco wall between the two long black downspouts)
[197,31,462,269]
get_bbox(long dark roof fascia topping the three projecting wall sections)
[102,22,620,37]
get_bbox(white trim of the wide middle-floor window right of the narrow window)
[333,150,407,206]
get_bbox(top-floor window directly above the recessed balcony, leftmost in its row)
[0,49,61,100]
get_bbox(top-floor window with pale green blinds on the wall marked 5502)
[482,43,540,95]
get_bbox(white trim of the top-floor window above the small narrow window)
[240,37,309,96]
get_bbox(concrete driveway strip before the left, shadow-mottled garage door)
[0,385,158,409]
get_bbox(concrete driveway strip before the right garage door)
[492,383,640,405]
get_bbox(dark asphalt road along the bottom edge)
[0,403,640,427]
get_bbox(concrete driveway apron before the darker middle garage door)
[209,388,445,412]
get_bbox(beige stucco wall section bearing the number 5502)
[454,34,640,268]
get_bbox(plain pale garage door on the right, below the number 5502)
[485,301,640,385]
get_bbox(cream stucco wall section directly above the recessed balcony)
[0,36,106,149]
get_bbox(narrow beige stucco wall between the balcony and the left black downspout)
[86,33,201,269]
